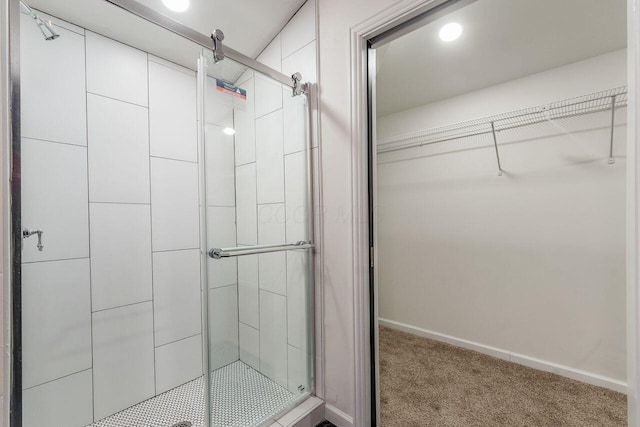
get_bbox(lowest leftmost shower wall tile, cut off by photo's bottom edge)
[22,370,93,427]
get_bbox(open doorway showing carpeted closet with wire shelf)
[369,0,628,427]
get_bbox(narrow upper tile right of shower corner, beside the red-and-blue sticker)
[233,77,256,165]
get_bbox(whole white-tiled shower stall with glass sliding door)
[3,0,314,427]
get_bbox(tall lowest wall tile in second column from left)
[93,302,155,420]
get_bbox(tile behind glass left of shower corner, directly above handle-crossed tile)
[205,124,236,206]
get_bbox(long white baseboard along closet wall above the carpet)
[380,319,627,394]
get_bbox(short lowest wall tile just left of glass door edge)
[156,335,202,394]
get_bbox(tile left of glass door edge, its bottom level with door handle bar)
[151,158,200,251]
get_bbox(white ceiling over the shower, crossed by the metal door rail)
[26,0,305,64]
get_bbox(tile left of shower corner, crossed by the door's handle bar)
[207,207,238,288]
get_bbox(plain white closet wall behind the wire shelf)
[378,50,626,390]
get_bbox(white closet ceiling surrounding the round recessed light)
[377,0,626,116]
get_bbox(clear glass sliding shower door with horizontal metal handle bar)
[200,51,313,426]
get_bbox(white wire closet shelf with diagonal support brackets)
[377,86,627,174]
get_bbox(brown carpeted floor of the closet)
[380,327,627,427]
